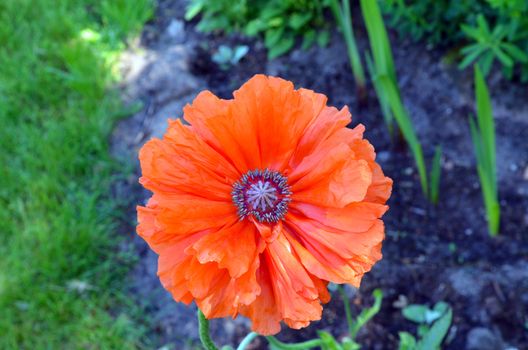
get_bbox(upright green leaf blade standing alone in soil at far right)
[469,66,500,236]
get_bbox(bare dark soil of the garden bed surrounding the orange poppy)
[113,0,528,349]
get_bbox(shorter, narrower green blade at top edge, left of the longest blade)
[330,0,365,92]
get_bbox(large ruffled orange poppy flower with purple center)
[137,75,392,335]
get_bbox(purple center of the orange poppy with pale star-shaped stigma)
[231,169,291,223]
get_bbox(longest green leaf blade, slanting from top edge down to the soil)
[360,0,441,203]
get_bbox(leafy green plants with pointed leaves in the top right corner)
[382,0,528,81]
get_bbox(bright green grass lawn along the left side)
[0,0,152,349]
